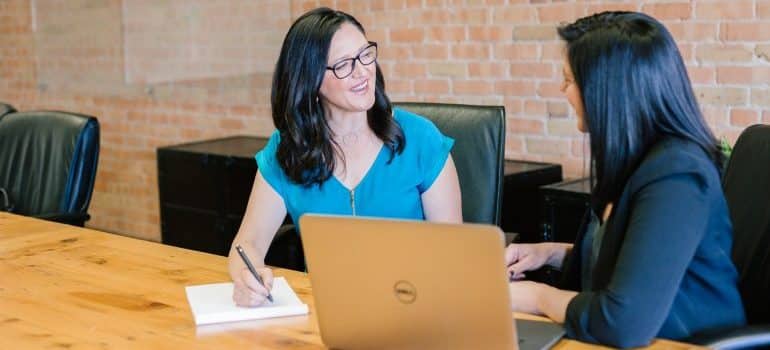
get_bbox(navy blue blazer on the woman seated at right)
[562,138,746,347]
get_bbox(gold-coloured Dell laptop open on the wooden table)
[299,215,563,349]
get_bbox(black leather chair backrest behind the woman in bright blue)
[394,102,505,226]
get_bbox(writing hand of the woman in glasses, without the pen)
[228,253,273,307]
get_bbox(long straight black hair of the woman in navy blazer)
[558,12,723,213]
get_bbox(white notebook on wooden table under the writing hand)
[185,277,308,325]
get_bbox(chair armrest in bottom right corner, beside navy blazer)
[685,324,770,349]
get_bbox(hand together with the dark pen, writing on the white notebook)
[230,245,273,306]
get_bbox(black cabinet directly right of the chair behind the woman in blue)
[500,160,562,242]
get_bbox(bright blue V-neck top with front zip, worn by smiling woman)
[255,108,454,231]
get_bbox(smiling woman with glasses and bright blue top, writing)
[229,8,462,306]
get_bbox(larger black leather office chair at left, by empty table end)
[0,111,99,226]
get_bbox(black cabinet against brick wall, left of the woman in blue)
[157,136,267,255]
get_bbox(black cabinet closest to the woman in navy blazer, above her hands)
[540,178,591,243]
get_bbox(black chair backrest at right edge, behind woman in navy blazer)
[723,125,770,324]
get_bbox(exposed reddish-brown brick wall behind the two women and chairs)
[0,0,770,240]
